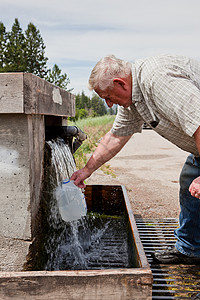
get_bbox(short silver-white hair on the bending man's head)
[88,55,131,91]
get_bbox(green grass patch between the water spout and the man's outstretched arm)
[68,115,115,177]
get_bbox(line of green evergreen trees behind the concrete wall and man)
[0,18,116,119]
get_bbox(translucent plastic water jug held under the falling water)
[56,180,87,222]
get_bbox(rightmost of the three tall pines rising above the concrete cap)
[25,23,48,78]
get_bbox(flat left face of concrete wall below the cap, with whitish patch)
[0,114,31,239]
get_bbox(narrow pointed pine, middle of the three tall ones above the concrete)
[4,19,26,72]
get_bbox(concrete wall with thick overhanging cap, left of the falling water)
[0,73,75,271]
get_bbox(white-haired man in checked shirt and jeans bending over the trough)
[71,55,200,264]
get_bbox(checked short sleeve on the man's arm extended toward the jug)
[111,105,144,136]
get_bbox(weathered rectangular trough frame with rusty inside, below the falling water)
[0,185,152,300]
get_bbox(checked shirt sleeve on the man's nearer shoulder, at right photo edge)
[146,69,200,136]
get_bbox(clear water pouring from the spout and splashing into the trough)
[45,139,132,270]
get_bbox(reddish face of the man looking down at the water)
[95,78,132,108]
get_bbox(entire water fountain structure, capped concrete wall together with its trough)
[0,73,152,300]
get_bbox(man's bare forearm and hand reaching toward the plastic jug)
[71,131,131,188]
